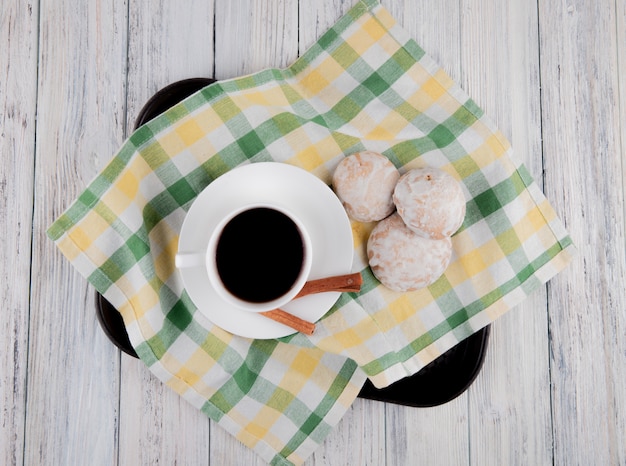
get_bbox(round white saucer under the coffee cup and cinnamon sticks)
[179,162,353,339]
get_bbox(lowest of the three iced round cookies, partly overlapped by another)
[367,213,452,291]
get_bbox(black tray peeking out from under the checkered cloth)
[96,78,490,408]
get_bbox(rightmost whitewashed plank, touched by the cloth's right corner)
[539,0,626,465]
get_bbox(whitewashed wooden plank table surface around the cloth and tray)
[0,0,626,465]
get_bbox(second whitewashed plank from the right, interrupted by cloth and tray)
[461,0,552,464]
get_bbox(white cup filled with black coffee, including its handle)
[176,203,312,312]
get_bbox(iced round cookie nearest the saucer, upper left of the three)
[332,151,400,222]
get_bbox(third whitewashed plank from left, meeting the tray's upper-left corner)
[119,0,214,465]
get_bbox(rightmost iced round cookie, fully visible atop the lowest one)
[393,167,465,239]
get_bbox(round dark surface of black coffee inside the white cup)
[216,207,304,303]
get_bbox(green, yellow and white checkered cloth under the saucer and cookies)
[48,0,574,464]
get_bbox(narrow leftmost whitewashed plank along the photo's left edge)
[0,0,38,465]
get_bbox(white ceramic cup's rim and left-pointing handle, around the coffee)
[175,202,313,312]
